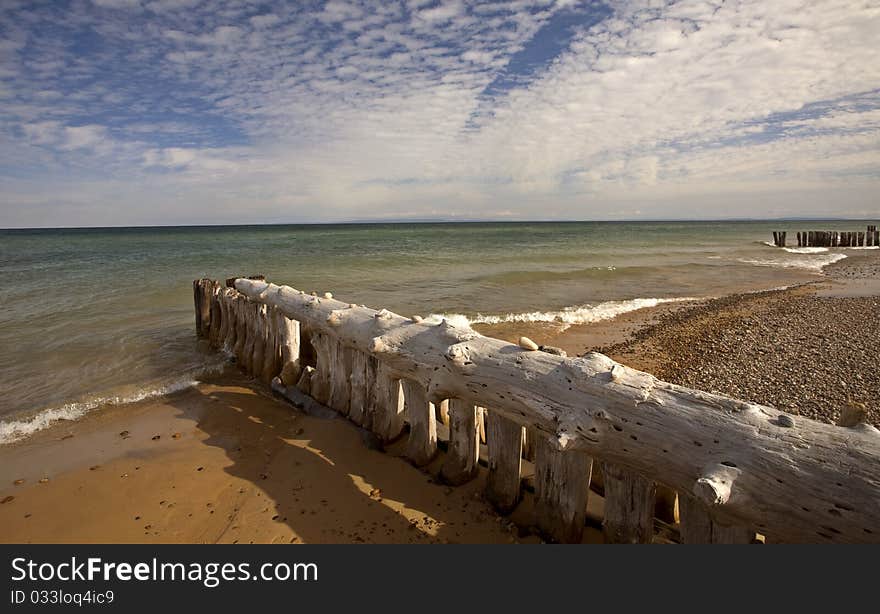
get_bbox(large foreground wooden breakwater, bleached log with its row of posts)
[193,278,880,543]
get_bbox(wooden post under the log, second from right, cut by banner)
[602,462,656,544]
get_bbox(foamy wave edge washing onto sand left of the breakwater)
[0,367,223,445]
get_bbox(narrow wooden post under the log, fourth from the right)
[486,409,523,514]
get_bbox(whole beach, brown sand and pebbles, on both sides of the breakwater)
[0,248,880,543]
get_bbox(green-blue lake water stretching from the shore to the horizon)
[0,222,865,442]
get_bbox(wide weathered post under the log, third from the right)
[535,435,593,544]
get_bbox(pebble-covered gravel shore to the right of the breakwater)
[599,256,880,426]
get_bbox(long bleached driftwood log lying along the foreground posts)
[235,279,880,542]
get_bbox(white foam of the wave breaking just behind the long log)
[426,297,696,330]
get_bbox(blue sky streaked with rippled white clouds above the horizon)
[0,0,880,227]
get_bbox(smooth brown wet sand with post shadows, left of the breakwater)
[0,376,538,543]
